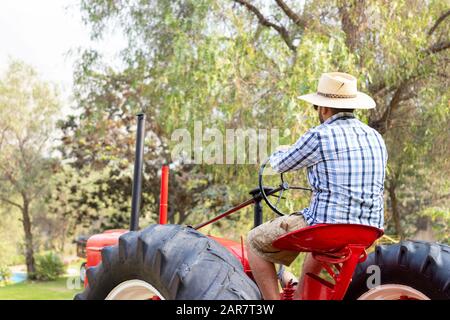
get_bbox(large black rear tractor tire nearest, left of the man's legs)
[75,224,261,300]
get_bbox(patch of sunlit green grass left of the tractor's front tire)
[0,277,82,300]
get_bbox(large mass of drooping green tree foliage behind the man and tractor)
[56,0,449,242]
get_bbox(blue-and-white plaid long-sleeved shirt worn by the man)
[270,112,387,228]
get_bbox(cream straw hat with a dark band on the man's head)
[298,72,375,109]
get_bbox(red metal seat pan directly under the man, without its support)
[273,224,383,254]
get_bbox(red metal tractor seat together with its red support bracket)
[273,224,383,300]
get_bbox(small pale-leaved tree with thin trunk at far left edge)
[0,61,59,278]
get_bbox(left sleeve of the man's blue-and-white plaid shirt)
[269,130,321,172]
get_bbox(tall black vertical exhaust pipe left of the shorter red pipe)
[130,113,145,231]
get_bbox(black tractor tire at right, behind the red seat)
[345,241,450,300]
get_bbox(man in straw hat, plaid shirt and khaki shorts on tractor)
[247,72,387,300]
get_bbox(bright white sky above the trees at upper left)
[0,0,125,102]
